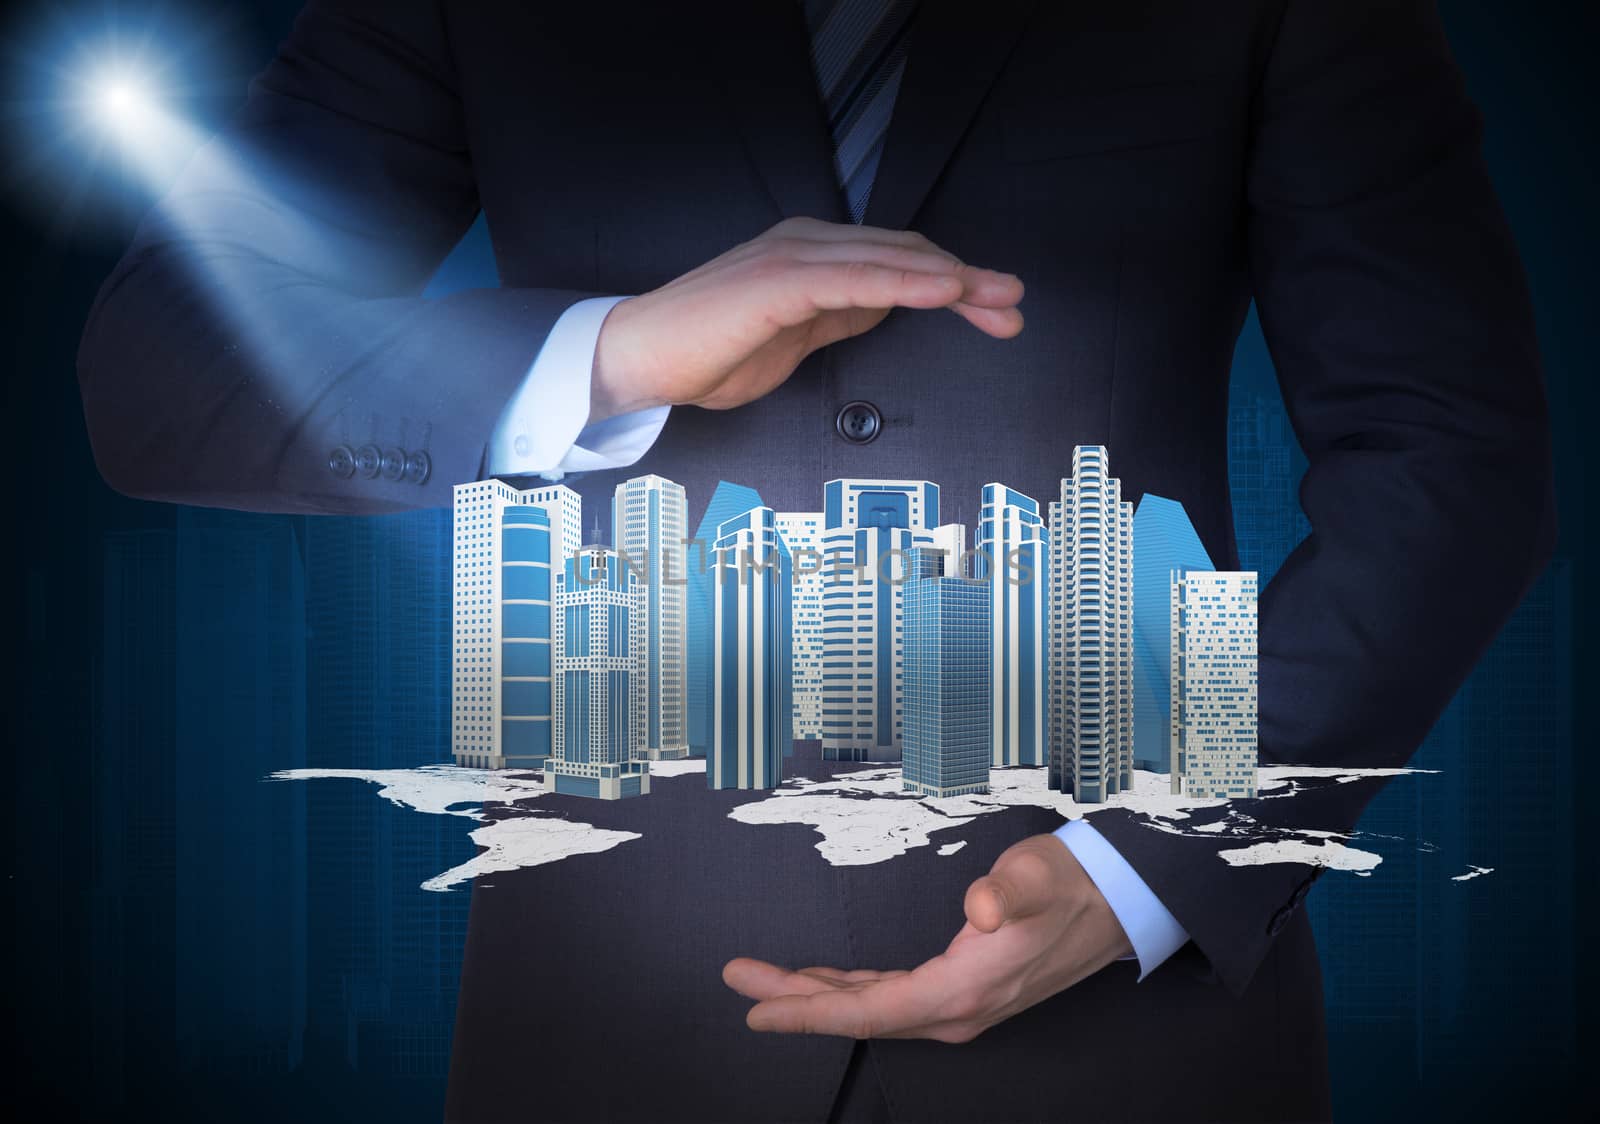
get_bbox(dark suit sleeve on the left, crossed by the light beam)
[78,0,594,512]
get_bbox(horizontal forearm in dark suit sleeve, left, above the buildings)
[78,224,601,514]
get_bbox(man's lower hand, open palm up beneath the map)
[722,836,1133,1042]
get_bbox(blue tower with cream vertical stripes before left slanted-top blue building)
[706,508,794,788]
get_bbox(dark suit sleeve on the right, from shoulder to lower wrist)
[1094,0,1555,991]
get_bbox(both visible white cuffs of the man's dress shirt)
[488,296,1189,980]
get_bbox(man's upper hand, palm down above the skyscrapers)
[589,218,1022,421]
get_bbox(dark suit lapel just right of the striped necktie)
[864,0,1035,231]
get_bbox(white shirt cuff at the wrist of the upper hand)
[488,296,672,480]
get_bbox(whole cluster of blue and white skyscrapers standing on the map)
[453,445,1258,804]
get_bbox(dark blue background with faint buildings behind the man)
[0,0,1597,1121]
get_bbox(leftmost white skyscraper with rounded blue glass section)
[450,480,582,769]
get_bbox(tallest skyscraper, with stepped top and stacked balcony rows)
[1050,445,1133,804]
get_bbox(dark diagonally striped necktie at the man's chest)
[802,0,917,223]
